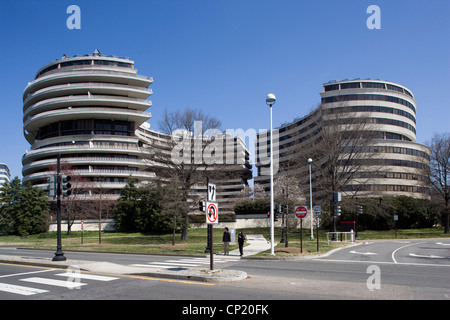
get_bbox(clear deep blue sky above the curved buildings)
[0,0,450,178]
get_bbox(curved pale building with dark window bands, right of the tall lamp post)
[255,79,430,198]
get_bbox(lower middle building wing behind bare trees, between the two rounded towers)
[136,123,252,213]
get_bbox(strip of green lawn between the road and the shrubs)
[0,228,450,256]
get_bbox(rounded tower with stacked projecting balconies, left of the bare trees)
[22,50,251,212]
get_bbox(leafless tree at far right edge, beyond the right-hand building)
[428,133,450,233]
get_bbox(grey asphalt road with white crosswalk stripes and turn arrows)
[0,239,450,302]
